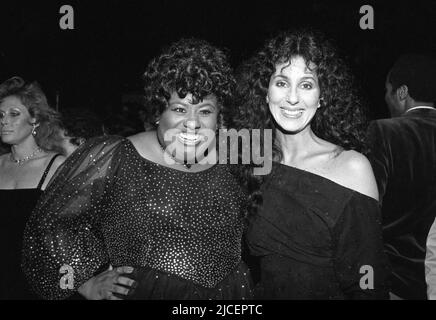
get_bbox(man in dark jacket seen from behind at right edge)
[369,55,436,299]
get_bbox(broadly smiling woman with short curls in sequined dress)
[23,39,251,299]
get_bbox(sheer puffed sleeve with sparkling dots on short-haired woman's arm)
[22,136,125,299]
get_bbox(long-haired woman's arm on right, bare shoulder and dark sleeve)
[333,151,390,299]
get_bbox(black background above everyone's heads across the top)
[0,0,436,118]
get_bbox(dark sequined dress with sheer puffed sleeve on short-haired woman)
[23,137,251,299]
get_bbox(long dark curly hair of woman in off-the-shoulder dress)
[229,29,368,216]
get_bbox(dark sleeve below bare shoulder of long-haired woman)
[333,193,390,299]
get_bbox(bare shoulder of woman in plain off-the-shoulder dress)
[335,150,378,200]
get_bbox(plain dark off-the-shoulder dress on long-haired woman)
[247,163,389,299]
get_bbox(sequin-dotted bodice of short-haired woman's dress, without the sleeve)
[102,141,242,287]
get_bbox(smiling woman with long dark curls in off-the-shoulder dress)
[233,30,387,299]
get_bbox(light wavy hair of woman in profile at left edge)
[0,77,61,152]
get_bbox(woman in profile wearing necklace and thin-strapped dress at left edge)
[0,77,64,300]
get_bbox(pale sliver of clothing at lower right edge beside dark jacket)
[425,216,436,300]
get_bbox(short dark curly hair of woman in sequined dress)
[143,38,235,122]
